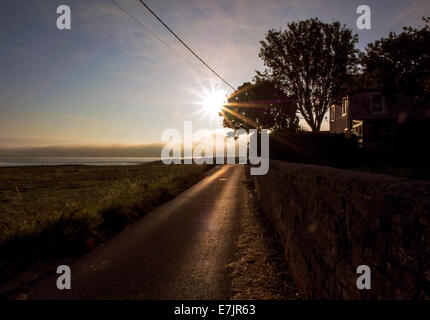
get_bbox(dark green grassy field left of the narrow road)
[0,162,210,282]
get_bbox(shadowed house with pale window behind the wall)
[330,89,430,147]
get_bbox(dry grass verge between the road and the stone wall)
[227,171,299,300]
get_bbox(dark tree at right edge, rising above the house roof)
[361,17,430,96]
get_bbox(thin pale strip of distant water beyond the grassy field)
[0,157,160,167]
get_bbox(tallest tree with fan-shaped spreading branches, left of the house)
[259,18,358,131]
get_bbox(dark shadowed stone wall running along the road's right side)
[252,160,430,299]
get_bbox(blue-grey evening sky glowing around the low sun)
[0,0,430,147]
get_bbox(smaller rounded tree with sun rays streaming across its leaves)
[222,77,299,132]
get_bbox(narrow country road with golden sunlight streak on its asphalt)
[22,165,248,299]
